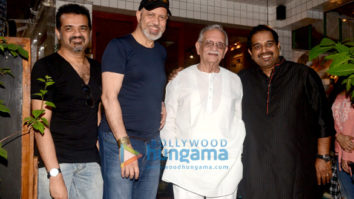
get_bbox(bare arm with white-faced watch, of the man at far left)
[31,99,68,199]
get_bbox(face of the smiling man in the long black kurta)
[248,31,280,69]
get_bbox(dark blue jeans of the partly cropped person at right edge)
[337,161,354,199]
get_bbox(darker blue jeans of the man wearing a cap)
[98,127,161,199]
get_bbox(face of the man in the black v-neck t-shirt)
[55,14,90,52]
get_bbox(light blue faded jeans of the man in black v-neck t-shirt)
[38,162,103,199]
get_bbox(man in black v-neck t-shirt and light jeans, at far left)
[31,4,103,199]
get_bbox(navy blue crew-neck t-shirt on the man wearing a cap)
[101,34,166,139]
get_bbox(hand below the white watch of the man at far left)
[49,173,68,199]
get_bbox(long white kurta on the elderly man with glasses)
[161,65,245,197]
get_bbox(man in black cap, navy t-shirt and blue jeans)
[99,0,170,199]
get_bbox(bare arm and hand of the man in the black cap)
[101,72,139,179]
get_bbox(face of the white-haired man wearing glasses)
[195,29,227,64]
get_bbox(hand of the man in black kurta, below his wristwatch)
[315,158,332,185]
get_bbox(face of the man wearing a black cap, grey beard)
[136,7,168,41]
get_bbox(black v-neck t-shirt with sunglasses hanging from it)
[31,53,101,166]
